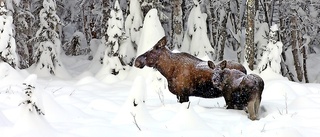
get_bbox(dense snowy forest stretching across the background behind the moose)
[0,0,320,83]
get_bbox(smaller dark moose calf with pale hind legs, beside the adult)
[210,61,264,120]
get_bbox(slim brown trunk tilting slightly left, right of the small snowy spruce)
[291,16,303,82]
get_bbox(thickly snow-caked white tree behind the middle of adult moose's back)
[183,0,214,59]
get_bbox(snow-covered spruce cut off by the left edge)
[0,1,19,68]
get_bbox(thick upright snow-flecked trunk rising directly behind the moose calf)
[245,0,256,70]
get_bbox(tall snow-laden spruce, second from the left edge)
[32,0,64,76]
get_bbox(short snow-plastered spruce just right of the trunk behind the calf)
[258,25,283,74]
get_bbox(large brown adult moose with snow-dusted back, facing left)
[134,36,246,103]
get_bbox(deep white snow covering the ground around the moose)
[0,54,320,137]
